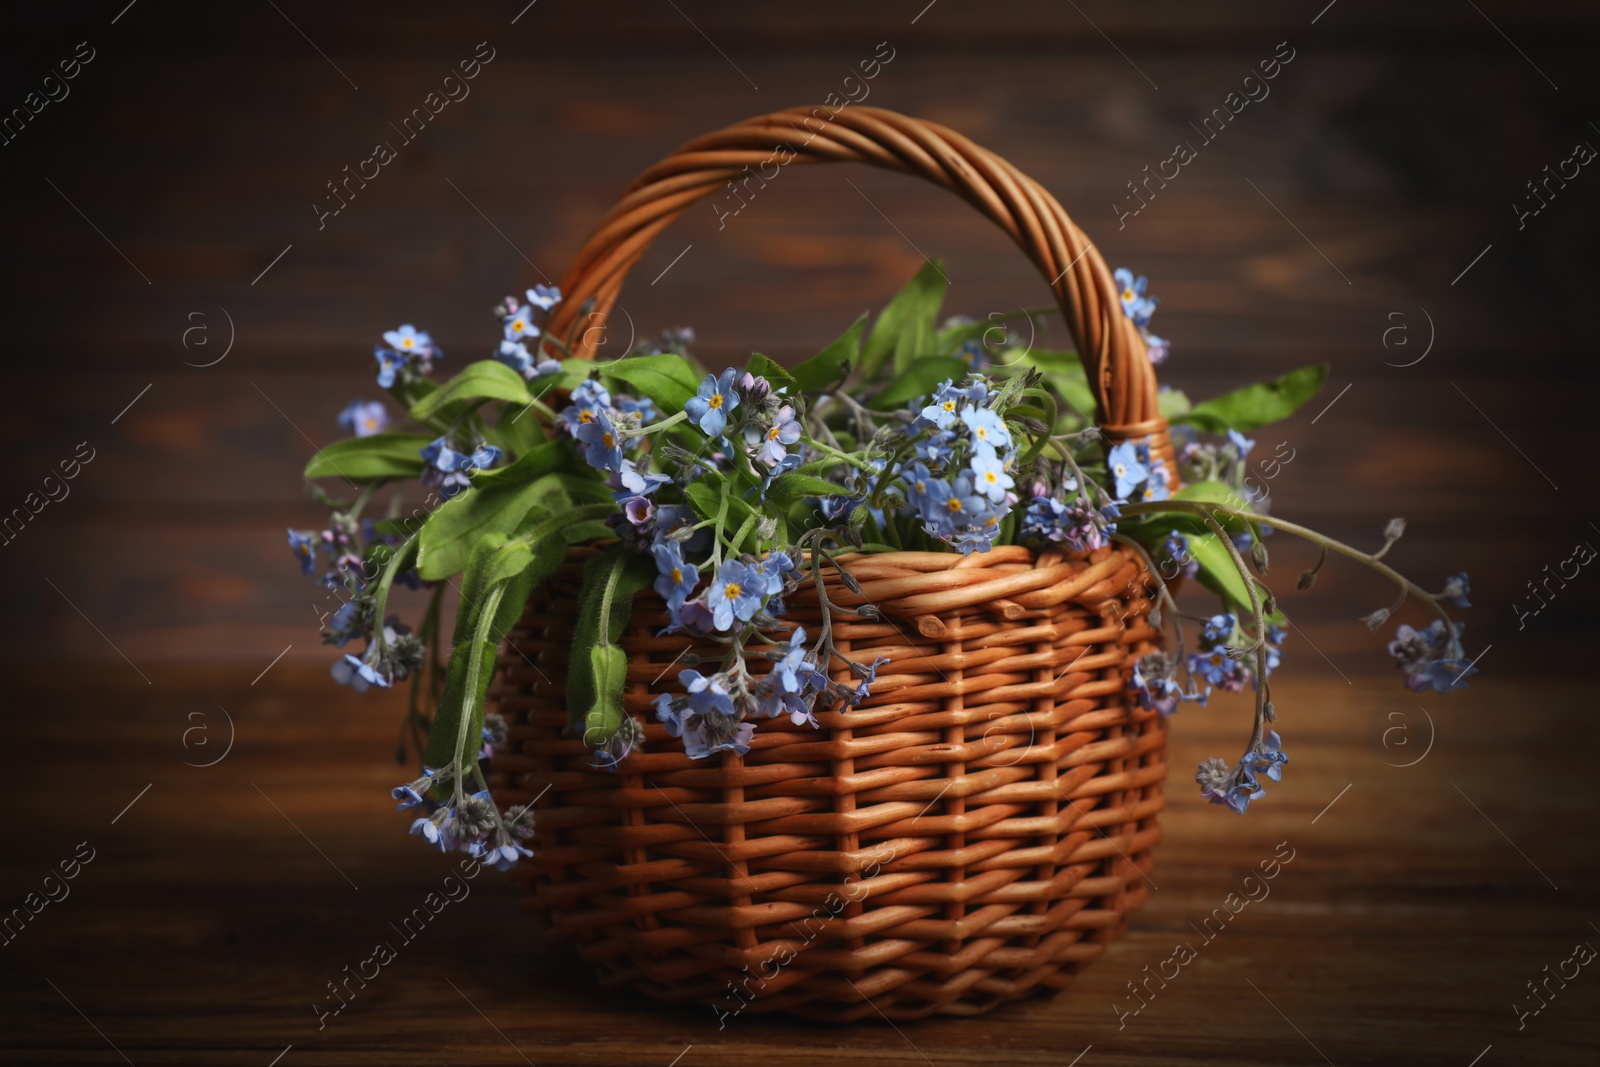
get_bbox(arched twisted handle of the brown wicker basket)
[547,106,1178,470]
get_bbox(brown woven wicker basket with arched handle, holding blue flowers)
[491,107,1176,1021]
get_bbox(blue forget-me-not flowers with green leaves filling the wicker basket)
[290,262,1475,869]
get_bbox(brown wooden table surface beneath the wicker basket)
[0,662,1600,1067]
